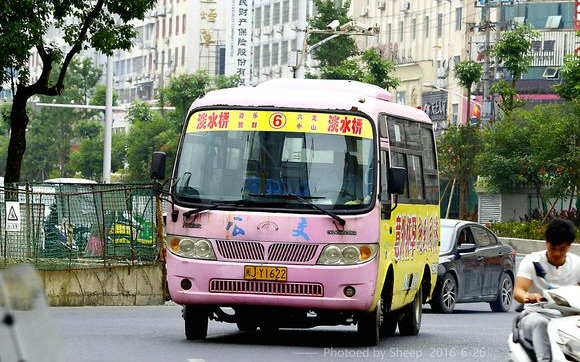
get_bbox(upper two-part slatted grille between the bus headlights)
[216,240,318,264]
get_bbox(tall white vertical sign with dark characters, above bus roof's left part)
[226,0,253,86]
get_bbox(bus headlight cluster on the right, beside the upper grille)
[316,244,379,265]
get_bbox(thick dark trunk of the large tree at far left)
[4,87,30,189]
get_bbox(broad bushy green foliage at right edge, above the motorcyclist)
[478,101,580,211]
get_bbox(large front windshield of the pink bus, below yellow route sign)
[174,110,375,210]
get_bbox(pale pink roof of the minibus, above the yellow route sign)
[190,78,431,123]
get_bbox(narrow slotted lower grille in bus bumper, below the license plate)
[209,279,324,297]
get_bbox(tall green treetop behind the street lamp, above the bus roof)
[307,0,358,68]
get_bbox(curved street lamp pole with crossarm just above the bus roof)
[292,20,379,78]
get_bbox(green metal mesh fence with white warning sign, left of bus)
[0,183,162,270]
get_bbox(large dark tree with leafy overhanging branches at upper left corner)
[0,0,156,183]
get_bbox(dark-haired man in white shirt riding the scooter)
[514,219,580,361]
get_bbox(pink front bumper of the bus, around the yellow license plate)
[167,253,378,311]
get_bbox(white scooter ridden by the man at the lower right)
[508,286,580,362]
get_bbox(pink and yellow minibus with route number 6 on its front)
[152,79,439,345]
